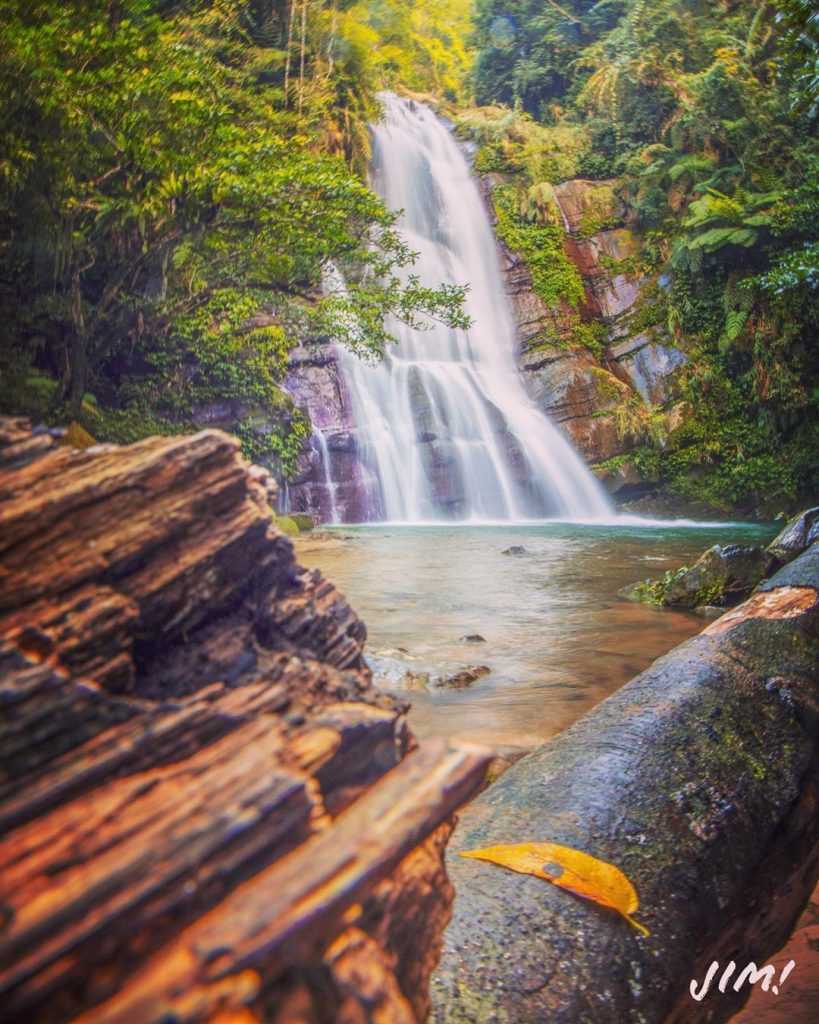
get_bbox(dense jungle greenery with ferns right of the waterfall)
[460,0,819,508]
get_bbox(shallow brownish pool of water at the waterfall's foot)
[298,523,775,750]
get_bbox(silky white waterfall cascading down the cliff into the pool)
[331,93,611,522]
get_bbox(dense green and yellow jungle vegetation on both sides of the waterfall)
[0,0,819,507]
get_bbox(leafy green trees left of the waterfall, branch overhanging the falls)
[0,0,464,469]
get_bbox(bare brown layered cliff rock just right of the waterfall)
[483,175,687,471]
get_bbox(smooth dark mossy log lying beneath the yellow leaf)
[433,544,819,1024]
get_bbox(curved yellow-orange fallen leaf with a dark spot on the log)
[461,843,649,935]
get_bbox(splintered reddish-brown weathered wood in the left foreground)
[0,421,487,1024]
